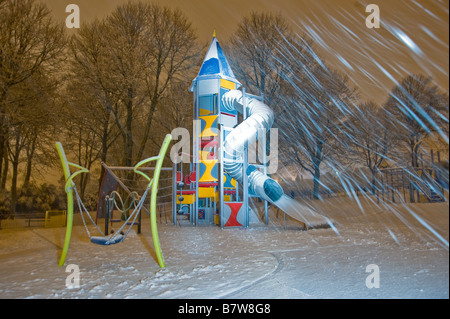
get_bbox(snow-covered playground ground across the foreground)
[0,197,449,299]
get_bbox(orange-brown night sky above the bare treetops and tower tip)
[42,0,449,104]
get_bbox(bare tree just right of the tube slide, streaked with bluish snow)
[277,37,358,199]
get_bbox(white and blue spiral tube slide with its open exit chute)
[222,90,331,228]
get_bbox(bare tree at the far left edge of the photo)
[0,0,65,189]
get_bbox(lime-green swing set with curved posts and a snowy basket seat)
[55,134,172,268]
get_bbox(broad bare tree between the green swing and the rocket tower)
[72,2,200,166]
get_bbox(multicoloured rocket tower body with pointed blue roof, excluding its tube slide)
[172,34,267,228]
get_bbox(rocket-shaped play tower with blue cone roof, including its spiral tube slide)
[173,33,330,228]
